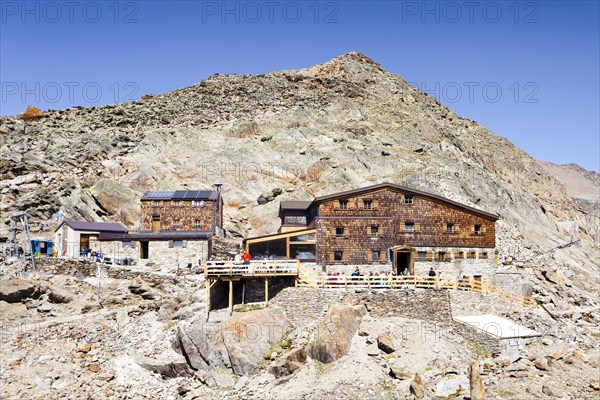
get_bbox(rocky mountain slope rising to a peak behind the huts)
[0,52,600,274]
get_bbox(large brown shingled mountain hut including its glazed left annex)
[247,183,498,270]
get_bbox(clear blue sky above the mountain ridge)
[0,0,600,171]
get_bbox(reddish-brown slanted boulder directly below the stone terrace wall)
[308,306,364,363]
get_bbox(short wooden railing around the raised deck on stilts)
[204,260,300,276]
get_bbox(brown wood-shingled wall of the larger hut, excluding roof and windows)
[316,189,495,264]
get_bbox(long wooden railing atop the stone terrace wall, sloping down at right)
[297,274,537,307]
